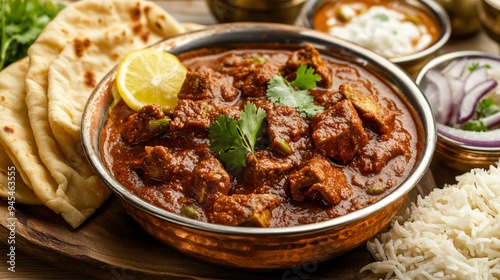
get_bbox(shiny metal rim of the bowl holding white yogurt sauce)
[300,0,451,64]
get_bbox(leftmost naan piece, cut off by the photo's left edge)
[0,58,42,204]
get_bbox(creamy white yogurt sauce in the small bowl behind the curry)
[329,5,432,57]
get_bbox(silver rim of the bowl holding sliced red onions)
[415,50,500,153]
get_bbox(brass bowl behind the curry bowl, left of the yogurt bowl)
[206,0,307,24]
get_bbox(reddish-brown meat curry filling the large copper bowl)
[101,44,419,227]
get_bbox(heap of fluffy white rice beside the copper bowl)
[361,163,500,280]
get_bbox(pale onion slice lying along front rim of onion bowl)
[437,123,500,148]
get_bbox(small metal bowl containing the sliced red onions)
[416,51,500,174]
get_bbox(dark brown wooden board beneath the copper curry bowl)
[0,172,436,280]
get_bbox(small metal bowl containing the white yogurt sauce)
[300,0,454,76]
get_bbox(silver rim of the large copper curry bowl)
[81,23,436,236]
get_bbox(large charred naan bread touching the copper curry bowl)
[20,0,185,228]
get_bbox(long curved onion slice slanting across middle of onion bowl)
[456,79,497,124]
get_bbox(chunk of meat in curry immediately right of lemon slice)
[178,71,239,102]
